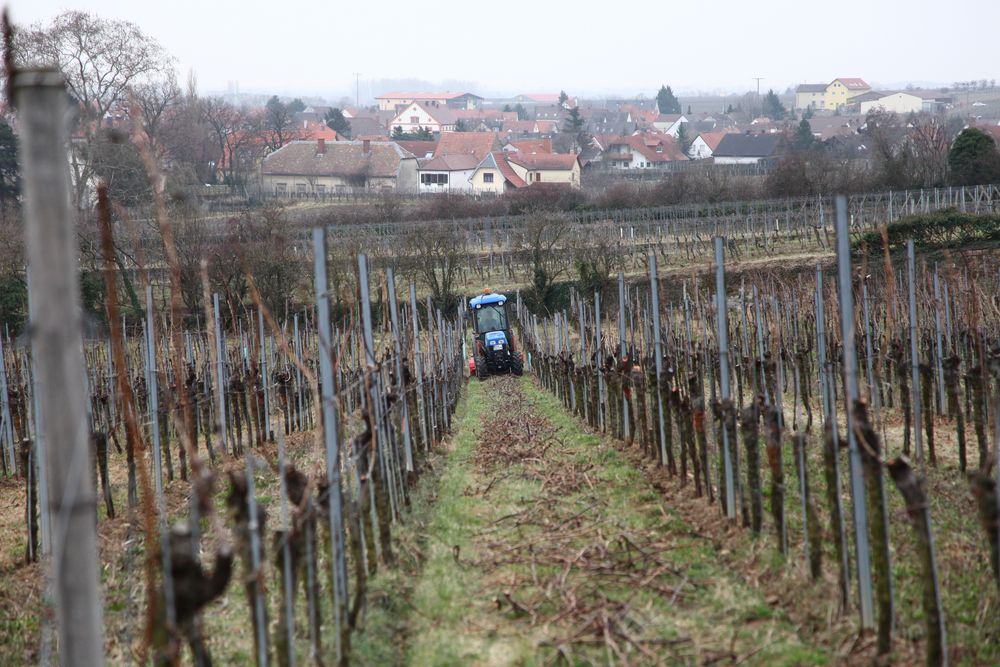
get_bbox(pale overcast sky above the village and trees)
[8,0,1000,99]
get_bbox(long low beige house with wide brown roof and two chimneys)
[260,139,417,197]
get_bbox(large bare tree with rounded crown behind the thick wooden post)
[13,11,173,210]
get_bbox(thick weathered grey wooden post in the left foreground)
[13,69,104,665]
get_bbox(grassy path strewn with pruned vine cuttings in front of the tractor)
[388,378,830,665]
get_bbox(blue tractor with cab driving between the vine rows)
[469,289,524,380]
